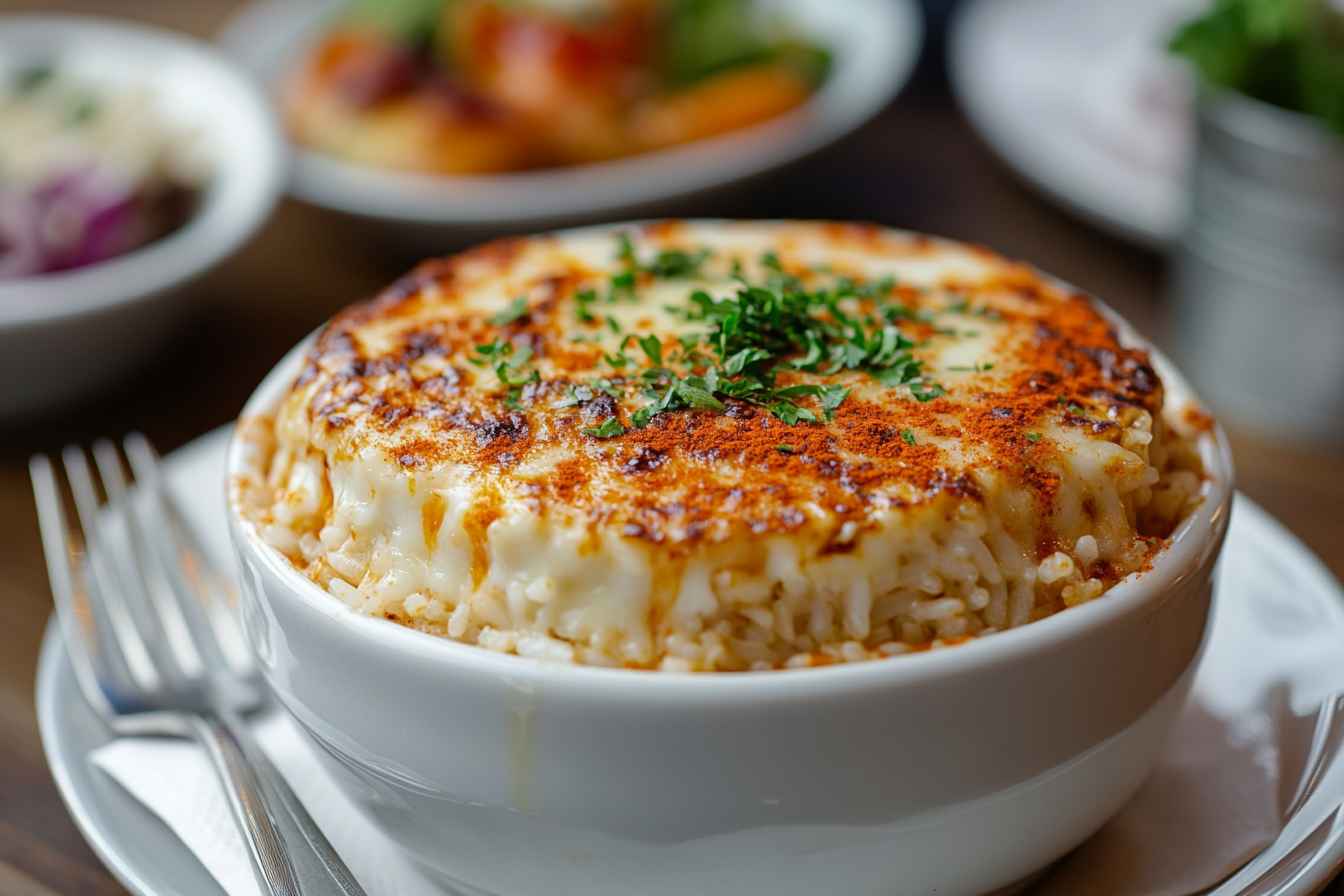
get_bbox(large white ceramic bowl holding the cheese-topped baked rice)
[228,231,1232,896]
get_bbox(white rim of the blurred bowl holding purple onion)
[0,13,285,326]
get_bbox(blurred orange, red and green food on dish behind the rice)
[285,0,828,175]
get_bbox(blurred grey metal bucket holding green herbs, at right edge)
[1171,85,1344,443]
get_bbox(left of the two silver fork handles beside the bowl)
[192,715,304,896]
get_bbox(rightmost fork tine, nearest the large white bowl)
[122,433,255,677]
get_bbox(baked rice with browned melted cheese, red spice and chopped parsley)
[231,222,1203,670]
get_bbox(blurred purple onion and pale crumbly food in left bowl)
[0,64,208,279]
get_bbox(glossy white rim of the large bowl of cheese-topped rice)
[223,219,1234,700]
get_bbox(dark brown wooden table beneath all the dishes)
[0,0,1344,896]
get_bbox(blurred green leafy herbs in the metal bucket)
[1169,0,1344,134]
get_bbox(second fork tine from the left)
[62,445,163,692]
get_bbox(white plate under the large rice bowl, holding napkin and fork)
[38,429,1344,896]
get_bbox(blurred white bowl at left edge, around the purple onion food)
[0,15,284,416]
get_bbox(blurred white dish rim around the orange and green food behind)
[219,0,922,227]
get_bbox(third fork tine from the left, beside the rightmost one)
[93,439,204,680]
